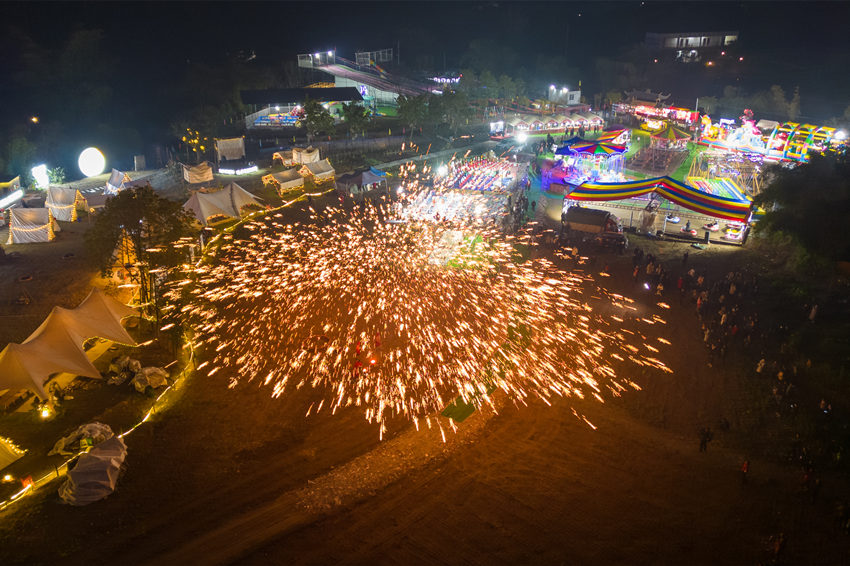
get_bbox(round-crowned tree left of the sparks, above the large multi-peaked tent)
[85,185,195,310]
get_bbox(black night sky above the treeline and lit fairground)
[0,1,850,146]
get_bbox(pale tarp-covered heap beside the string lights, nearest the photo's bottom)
[59,436,127,505]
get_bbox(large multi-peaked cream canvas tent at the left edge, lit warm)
[0,289,136,399]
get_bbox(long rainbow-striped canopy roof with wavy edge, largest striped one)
[567,177,752,222]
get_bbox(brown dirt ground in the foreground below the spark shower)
[0,193,850,565]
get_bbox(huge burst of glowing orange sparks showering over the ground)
[171,193,669,430]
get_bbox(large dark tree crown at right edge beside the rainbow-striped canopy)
[755,152,850,260]
